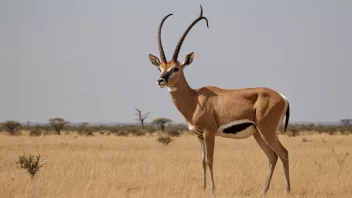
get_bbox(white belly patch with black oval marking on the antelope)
[216,120,257,139]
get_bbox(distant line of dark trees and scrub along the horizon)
[0,108,352,136]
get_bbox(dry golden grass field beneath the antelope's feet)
[0,131,352,198]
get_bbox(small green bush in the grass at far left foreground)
[15,154,45,179]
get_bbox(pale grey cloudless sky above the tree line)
[0,0,352,122]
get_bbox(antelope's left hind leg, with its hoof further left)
[253,133,278,194]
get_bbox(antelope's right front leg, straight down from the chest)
[203,131,215,193]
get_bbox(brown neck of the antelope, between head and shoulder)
[169,73,197,121]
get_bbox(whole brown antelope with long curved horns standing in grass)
[149,5,291,194]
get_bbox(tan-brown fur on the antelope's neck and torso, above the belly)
[164,69,285,131]
